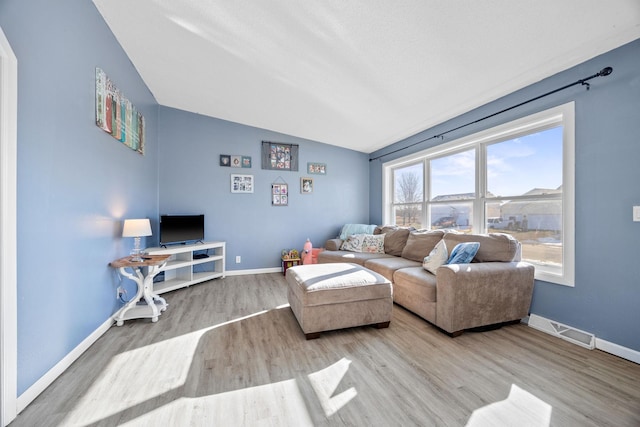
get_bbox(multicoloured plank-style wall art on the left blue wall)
[96,68,144,155]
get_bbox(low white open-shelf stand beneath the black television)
[145,242,225,294]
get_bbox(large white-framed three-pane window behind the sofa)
[384,103,574,286]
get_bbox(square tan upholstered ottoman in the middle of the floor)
[286,263,393,339]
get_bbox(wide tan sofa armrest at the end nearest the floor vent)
[436,262,535,333]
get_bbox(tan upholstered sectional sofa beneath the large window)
[318,226,534,336]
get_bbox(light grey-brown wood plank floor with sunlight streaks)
[11,274,640,427]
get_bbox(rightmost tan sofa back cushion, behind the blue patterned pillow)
[444,233,518,262]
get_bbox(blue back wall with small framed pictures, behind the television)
[159,107,369,270]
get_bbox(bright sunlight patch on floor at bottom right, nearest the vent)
[466,384,553,427]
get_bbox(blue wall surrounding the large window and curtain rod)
[369,40,640,351]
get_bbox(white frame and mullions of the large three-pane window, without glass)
[382,102,575,287]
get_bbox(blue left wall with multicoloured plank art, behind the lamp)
[0,0,158,394]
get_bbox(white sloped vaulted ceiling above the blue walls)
[93,0,640,153]
